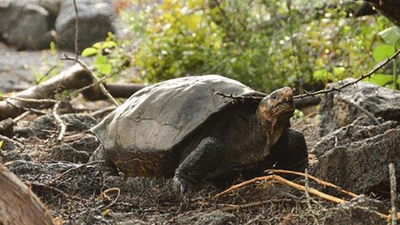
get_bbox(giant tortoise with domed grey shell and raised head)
[92,75,308,192]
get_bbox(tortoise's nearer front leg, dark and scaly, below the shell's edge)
[174,137,224,193]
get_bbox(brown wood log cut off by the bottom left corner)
[0,164,54,225]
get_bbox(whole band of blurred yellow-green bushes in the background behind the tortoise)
[114,0,398,91]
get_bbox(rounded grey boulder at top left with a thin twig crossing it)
[55,0,115,50]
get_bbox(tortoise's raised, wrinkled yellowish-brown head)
[257,87,294,145]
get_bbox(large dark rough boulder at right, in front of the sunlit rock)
[313,121,400,193]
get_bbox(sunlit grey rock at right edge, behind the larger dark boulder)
[320,79,400,136]
